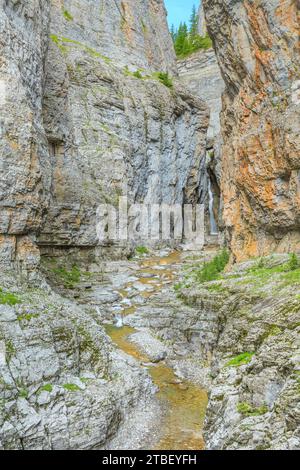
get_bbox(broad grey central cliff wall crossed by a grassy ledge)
[39,0,208,258]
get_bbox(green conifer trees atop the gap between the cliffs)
[171,6,212,58]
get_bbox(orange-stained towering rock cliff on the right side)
[203,0,300,259]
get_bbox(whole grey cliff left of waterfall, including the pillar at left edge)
[0,0,208,264]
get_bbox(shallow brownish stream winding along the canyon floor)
[106,252,207,450]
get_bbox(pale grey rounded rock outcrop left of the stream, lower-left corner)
[0,266,157,450]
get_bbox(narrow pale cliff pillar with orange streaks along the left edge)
[0,0,51,270]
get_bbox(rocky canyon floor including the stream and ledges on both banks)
[0,246,300,450]
